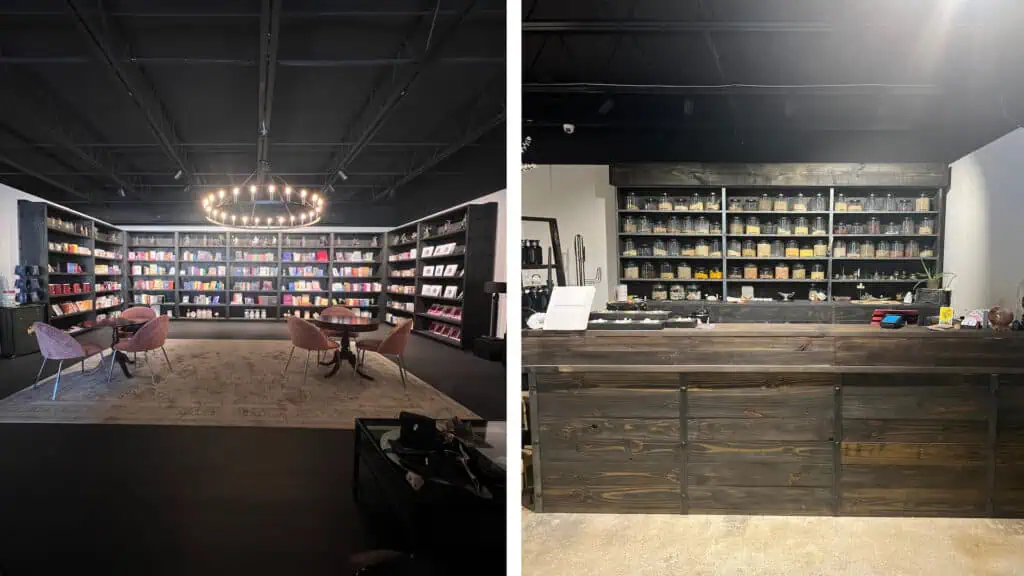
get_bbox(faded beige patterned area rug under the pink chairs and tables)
[0,340,476,428]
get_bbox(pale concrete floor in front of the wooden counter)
[522,511,1024,576]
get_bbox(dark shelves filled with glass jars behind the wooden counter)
[616,186,943,300]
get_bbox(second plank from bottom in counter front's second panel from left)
[686,462,833,488]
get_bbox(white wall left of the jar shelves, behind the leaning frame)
[522,165,618,310]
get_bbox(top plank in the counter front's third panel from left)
[843,383,989,421]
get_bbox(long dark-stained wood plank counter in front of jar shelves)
[522,324,1024,518]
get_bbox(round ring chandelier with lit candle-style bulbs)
[202,182,324,230]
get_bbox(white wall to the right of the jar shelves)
[943,128,1024,314]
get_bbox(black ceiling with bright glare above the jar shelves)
[522,0,1024,163]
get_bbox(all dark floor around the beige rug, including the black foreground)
[0,321,505,576]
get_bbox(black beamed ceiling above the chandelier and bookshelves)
[0,0,505,224]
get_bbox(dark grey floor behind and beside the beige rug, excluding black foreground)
[0,320,505,416]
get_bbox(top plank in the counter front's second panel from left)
[686,386,833,420]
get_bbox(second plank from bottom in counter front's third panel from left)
[840,464,985,491]
